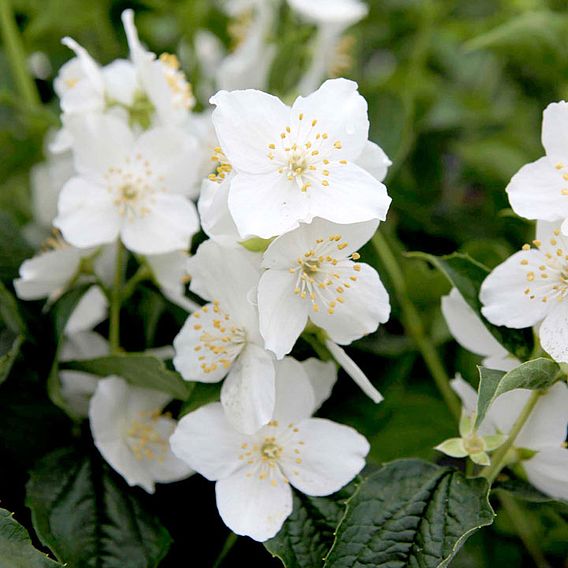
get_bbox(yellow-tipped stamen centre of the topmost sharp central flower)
[267,113,347,192]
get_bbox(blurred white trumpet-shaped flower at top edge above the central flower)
[288,0,368,94]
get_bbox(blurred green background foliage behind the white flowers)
[0,0,568,568]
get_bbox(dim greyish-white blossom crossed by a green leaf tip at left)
[59,331,109,417]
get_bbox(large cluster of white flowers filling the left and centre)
[15,5,391,540]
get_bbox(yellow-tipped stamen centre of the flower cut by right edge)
[521,229,568,303]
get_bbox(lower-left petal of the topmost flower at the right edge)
[507,157,568,225]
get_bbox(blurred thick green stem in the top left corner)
[0,0,41,107]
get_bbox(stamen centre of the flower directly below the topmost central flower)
[289,235,361,315]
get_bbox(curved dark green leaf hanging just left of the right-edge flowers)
[408,252,533,360]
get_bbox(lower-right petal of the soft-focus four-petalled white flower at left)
[121,193,199,254]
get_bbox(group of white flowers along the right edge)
[437,102,568,499]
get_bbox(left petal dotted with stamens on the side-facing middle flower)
[173,304,242,383]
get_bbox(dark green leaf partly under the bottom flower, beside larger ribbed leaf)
[264,479,360,568]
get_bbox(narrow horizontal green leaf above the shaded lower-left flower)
[61,353,190,400]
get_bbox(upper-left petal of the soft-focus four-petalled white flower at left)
[64,113,134,180]
